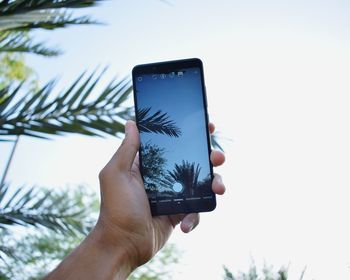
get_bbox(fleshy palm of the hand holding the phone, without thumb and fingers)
[98,157,174,266]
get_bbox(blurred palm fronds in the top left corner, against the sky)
[0,0,102,56]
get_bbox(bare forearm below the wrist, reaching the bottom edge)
[45,226,133,280]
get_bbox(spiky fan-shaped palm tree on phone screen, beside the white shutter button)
[166,160,201,195]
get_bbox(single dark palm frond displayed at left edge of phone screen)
[137,108,181,137]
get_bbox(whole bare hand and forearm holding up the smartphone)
[45,121,225,280]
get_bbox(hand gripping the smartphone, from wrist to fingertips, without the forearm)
[95,121,225,269]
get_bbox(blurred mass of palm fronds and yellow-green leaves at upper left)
[0,0,133,140]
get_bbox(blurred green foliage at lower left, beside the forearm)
[0,186,99,280]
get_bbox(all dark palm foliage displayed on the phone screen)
[137,107,211,199]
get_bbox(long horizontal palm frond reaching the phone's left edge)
[0,71,132,139]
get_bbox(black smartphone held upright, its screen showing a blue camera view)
[132,58,216,215]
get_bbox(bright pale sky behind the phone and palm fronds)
[1,0,350,279]
